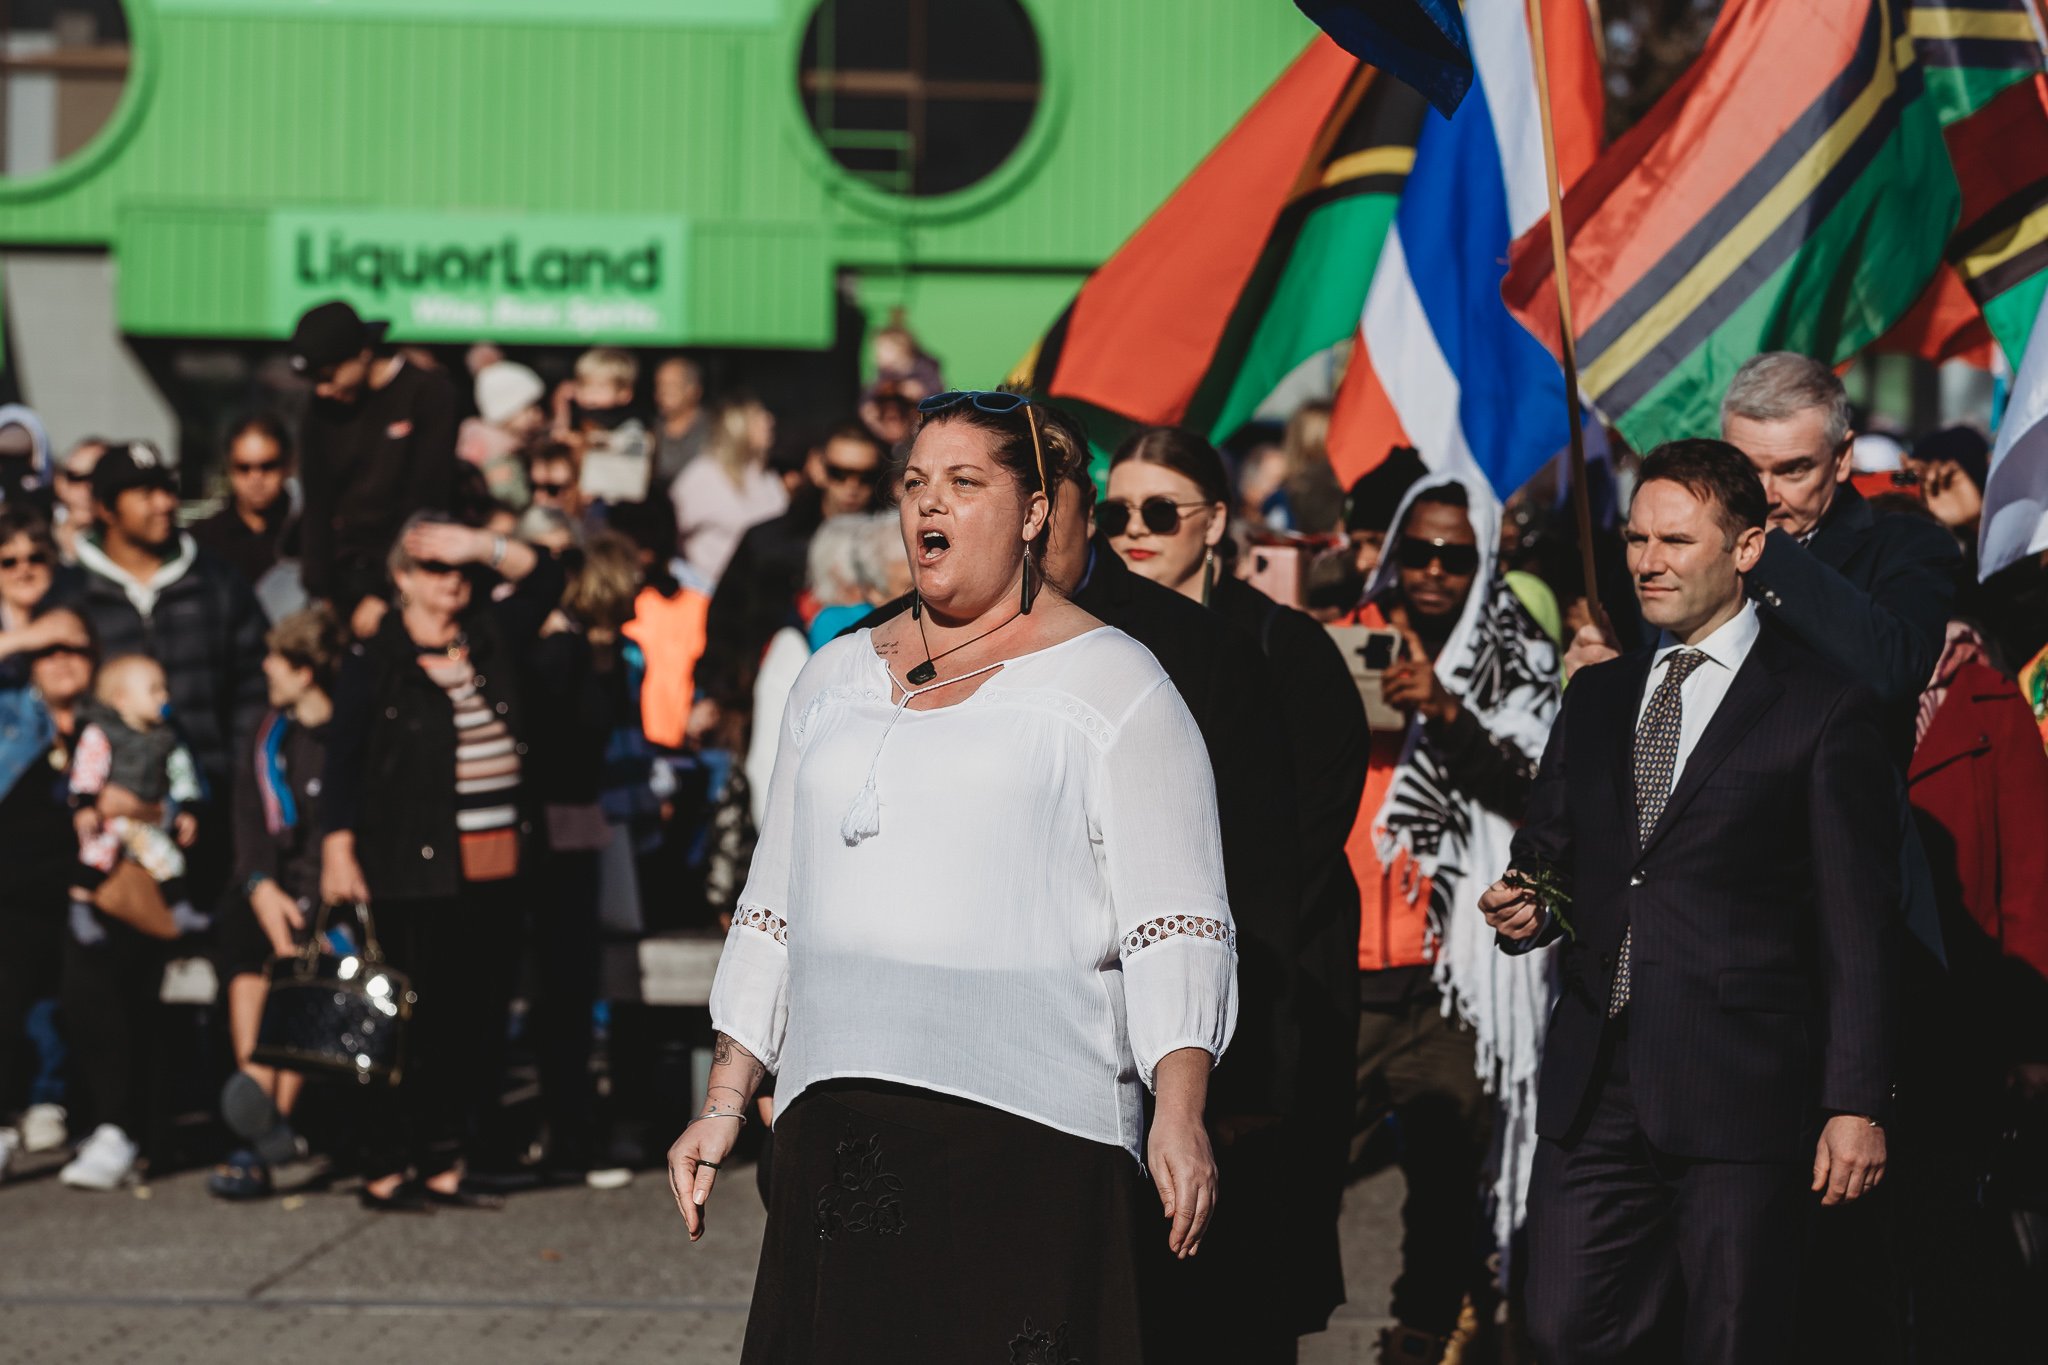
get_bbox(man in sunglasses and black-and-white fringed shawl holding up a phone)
[1346,475,1559,1359]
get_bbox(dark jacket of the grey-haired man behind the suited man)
[1747,485,1962,767]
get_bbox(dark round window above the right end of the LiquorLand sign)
[799,0,1042,196]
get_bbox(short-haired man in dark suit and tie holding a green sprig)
[1481,440,1903,1365]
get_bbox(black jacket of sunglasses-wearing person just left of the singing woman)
[696,487,825,706]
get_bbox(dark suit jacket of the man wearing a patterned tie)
[1503,624,1905,1160]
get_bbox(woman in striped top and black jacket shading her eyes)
[319,514,561,1212]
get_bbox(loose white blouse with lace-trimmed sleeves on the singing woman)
[711,626,1237,1160]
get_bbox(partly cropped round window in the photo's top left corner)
[0,0,131,180]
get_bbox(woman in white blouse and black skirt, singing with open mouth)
[670,393,1237,1365]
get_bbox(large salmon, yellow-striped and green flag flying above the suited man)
[1503,0,2044,448]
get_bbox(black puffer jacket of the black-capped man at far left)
[57,536,268,800]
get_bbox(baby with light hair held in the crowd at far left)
[72,655,209,941]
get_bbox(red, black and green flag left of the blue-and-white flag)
[1012,39,1427,458]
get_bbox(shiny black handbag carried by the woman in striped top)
[250,902,416,1085]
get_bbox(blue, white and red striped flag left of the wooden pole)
[1329,0,1604,497]
